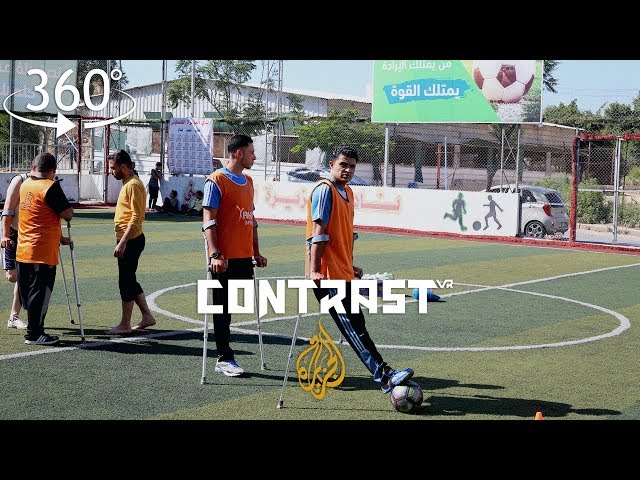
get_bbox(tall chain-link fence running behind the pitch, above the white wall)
[0,60,640,244]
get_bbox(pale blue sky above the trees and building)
[122,60,640,112]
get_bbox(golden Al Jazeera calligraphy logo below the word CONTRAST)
[296,320,345,400]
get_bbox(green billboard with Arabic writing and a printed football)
[371,60,543,123]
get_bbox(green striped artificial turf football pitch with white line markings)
[0,209,640,421]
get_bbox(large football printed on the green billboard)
[471,60,536,103]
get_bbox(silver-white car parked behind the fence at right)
[486,185,569,238]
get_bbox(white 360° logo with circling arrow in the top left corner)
[2,68,136,137]
